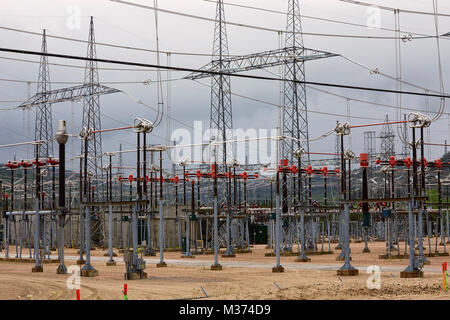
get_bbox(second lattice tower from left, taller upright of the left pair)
[81,17,103,197]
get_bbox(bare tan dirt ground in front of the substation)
[0,239,450,300]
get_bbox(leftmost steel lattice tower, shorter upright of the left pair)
[34,30,53,159]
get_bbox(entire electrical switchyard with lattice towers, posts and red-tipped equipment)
[0,0,450,296]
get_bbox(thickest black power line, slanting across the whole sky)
[0,46,450,99]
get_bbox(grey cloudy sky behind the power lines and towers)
[0,0,450,174]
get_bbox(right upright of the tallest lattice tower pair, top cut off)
[281,0,310,163]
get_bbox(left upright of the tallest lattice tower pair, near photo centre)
[210,0,233,168]
